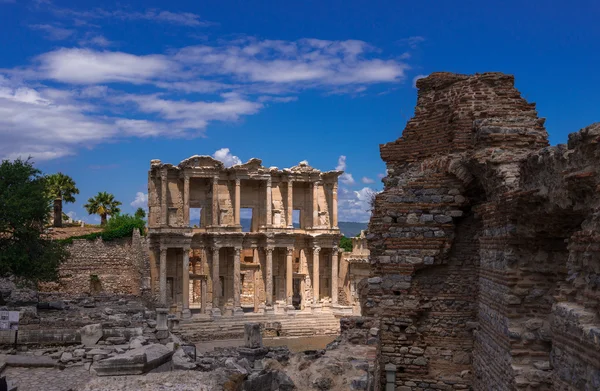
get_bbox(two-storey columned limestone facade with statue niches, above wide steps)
[148,156,351,318]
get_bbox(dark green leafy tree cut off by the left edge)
[0,159,68,282]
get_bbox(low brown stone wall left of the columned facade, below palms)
[39,231,149,295]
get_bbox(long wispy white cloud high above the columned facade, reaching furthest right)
[175,38,409,88]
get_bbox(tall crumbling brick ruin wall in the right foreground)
[361,73,600,391]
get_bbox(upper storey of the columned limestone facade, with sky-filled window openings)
[148,155,342,234]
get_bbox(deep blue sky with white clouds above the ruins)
[0,0,600,222]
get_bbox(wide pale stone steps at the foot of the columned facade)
[173,313,340,342]
